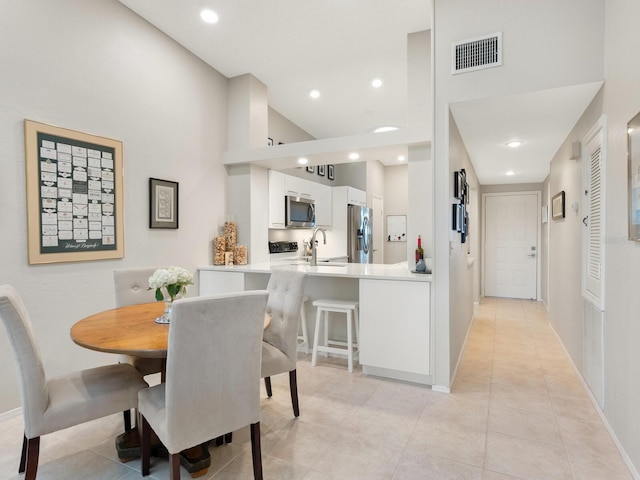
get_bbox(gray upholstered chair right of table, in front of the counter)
[262,270,307,417]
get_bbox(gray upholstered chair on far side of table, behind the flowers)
[113,267,164,431]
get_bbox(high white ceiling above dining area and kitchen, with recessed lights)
[120,0,431,142]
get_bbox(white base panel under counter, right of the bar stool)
[358,279,431,383]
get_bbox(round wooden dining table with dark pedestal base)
[70,302,271,477]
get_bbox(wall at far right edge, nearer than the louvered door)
[604,0,640,470]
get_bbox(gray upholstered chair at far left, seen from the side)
[0,285,147,480]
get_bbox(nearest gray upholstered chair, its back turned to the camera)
[138,290,268,480]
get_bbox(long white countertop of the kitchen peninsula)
[199,262,432,282]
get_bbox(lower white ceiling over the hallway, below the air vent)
[451,82,602,185]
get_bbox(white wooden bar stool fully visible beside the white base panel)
[311,298,359,373]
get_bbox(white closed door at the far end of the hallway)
[484,193,539,299]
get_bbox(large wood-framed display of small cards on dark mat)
[24,119,124,265]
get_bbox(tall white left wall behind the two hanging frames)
[0,0,227,412]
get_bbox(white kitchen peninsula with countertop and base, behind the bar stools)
[198,261,433,385]
